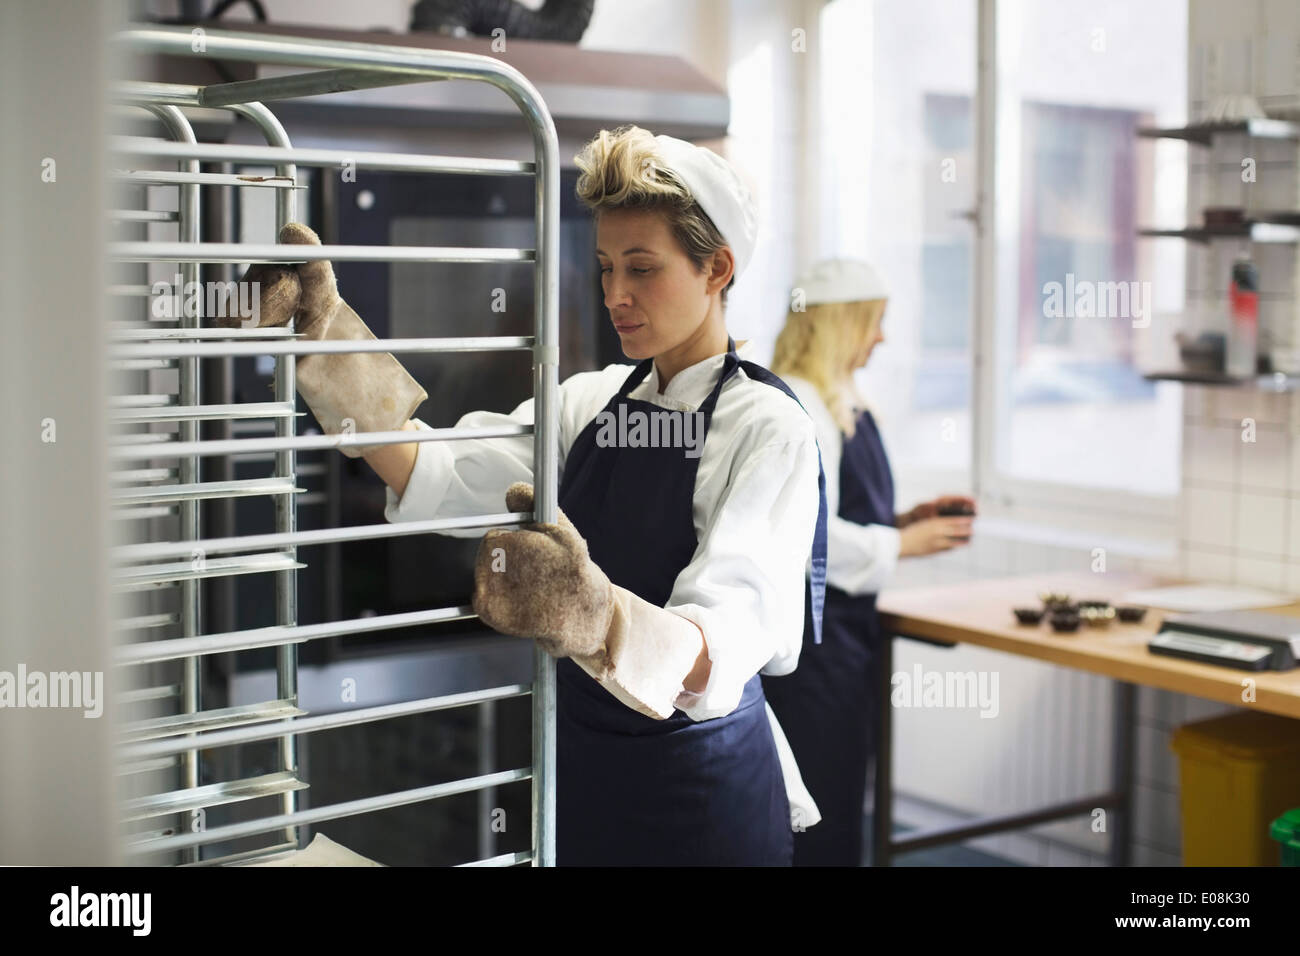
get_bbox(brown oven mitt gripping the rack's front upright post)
[473,481,703,719]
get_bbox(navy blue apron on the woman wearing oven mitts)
[555,337,826,866]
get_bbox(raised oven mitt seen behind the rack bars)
[215,222,429,458]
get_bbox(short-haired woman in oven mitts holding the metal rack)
[264,126,826,865]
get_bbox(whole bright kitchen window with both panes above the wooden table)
[818,0,1187,533]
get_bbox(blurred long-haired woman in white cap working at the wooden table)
[763,259,975,866]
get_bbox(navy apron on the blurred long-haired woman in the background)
[763,410,894,866]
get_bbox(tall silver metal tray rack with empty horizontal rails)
[108,27,560,866]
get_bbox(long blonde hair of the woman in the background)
[772,299,885,438]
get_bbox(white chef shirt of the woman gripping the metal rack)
[384,341,829,723]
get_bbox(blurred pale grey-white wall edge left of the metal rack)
[0,0,120,866]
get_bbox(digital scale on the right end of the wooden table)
[1147,611,1300,671]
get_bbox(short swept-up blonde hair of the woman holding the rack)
[573,125,736,306]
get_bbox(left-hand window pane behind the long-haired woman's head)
[807,0,976,494]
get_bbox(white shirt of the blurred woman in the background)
[781,375,901,596]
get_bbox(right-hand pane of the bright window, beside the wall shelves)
[980,0,1187,516]
